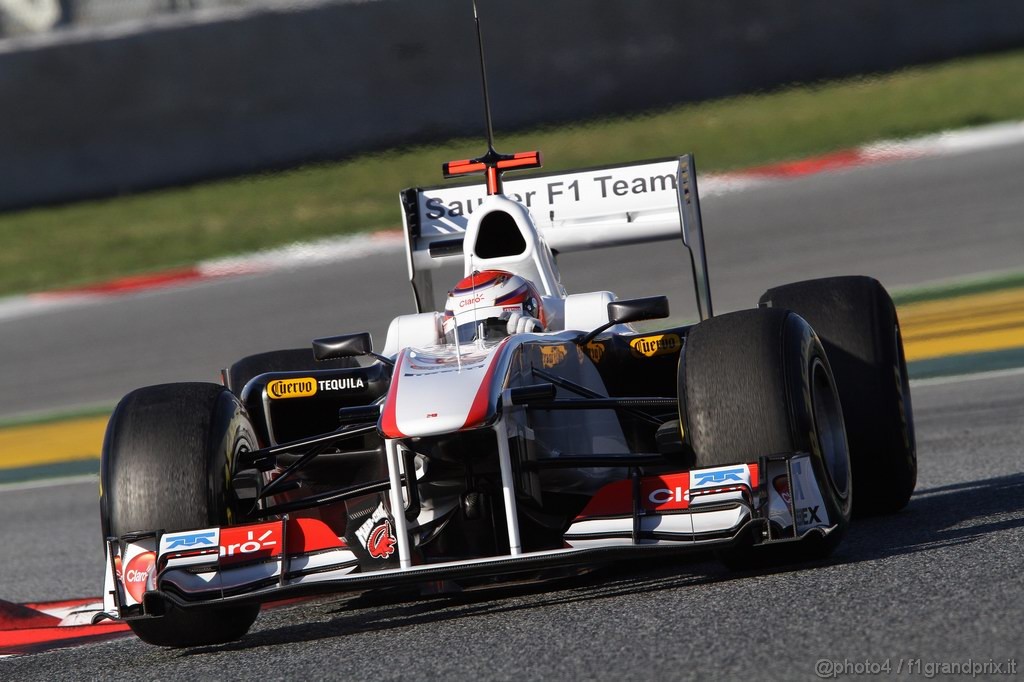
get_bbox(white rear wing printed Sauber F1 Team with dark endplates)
[400,155,713,319]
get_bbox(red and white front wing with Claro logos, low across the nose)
[100,453,836,620]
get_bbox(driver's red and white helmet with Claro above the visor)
[442,270,548,343]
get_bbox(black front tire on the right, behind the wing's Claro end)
[679,308,853,567]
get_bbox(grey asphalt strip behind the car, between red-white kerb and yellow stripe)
[0,144,1024,418]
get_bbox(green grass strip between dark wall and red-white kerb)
[6,51,1024,295]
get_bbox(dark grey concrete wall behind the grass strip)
[0,0,1024,208]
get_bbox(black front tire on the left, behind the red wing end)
[99,383,259,647]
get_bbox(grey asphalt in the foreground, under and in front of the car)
[0,368,1024,680]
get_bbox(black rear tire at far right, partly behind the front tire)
[760,276,918,516]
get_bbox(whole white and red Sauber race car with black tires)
[100,143,916,646]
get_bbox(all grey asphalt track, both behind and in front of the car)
[0,140,1024,679]
